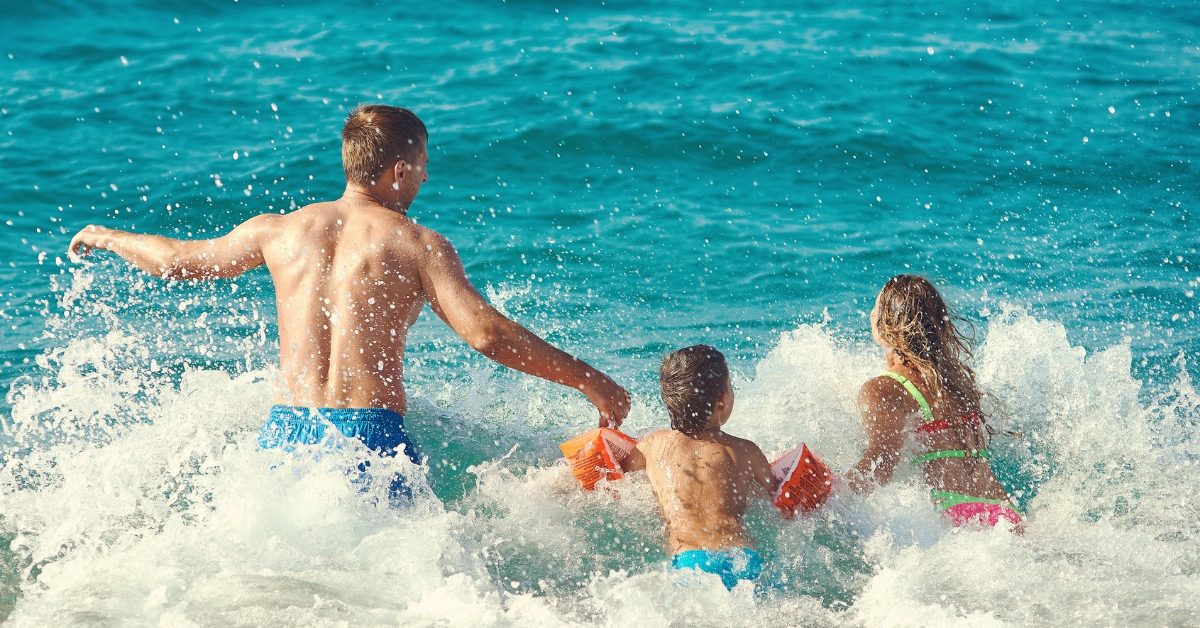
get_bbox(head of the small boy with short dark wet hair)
[659,345,730,435]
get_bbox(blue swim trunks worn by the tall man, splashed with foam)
[258,405,421,504]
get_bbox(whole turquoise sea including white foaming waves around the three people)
[0,0,1200,626]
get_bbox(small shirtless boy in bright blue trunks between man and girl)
[622,345,779,588]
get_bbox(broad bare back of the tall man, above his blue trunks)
[263,201,442,413]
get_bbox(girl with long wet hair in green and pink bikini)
[848,275,1021,530]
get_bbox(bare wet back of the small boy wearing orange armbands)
[637,430,774,554]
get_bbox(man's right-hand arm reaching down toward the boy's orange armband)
[421,232,629,426]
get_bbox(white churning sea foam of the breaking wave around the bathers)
[0,286,1200,626]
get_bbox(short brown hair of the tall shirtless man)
[342,104,430,186]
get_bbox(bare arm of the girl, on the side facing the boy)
[846,377,911,494]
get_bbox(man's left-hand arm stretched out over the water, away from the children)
[67,214,277,280]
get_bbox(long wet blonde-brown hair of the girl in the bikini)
[875,275,983,412]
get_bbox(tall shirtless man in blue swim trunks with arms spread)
[70,104,629,497]
